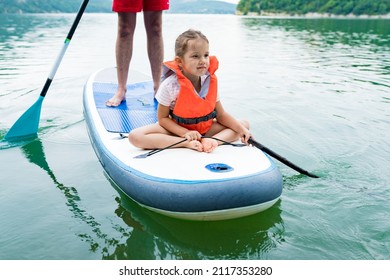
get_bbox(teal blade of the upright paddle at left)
[4,96,44,141]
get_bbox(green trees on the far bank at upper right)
[237,0,390,15]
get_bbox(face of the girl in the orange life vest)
[176,38,210,80]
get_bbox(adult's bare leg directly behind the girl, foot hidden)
[144,11,164,92]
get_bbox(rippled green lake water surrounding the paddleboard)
[0,14,390,260]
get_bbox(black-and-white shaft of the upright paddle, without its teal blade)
[40,0,89,97]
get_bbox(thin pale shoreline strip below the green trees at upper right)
[236,11,390,19]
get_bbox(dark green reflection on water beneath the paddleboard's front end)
[104,180,284,259]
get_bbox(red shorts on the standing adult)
[112,0,169,13]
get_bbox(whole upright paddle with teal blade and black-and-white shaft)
[4,0,89,141]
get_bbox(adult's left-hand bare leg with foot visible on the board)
[106,13,137,107]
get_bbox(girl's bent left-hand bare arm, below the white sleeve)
[157,104,202,141]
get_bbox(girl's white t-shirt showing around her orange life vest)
[156,73,219,110]
